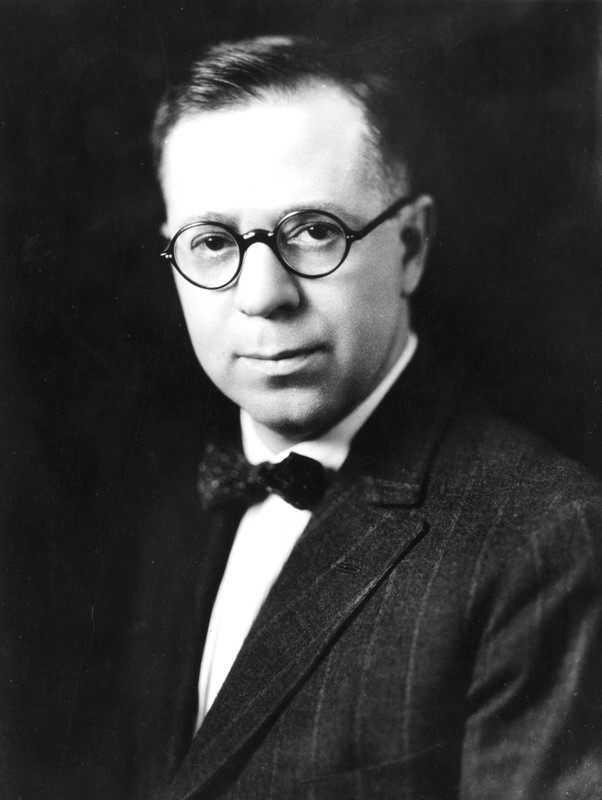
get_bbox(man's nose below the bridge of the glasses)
[235,242,301,317]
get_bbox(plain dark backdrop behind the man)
[0,0,602,798]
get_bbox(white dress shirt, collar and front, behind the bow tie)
[196,333,417,730]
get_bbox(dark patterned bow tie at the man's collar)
[198,444,328,510]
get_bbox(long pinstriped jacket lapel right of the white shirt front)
[171,344,464,800]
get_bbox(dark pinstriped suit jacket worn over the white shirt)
[12,346,602,800]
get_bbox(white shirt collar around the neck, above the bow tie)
[240,332,418,470]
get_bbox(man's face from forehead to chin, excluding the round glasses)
[162,85,428,450]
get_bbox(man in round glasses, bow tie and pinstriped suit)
[131,38,602,800]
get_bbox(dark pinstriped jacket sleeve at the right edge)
[460,500,602,800]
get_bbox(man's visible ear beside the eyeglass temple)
[400,194,436,297]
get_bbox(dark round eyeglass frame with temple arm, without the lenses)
[161,194,417,292]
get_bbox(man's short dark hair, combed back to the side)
[152,36,424,192]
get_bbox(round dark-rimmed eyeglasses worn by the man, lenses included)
[161,196,414,289]
